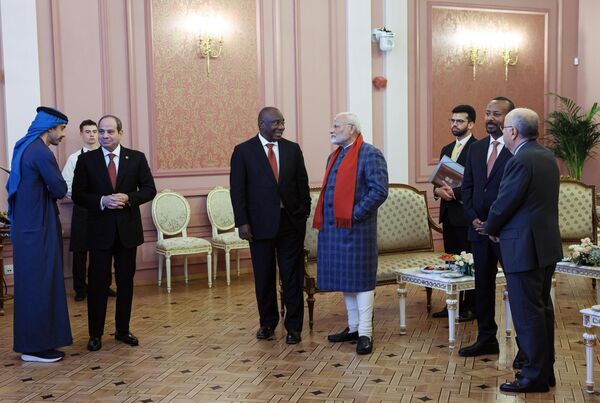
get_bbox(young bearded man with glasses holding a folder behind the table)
[432,105,477,322]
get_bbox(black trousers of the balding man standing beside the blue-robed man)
[88,230,137,336]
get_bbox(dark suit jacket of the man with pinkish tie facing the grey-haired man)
[462,136,512,242]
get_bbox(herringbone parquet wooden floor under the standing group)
[0,274,600,403]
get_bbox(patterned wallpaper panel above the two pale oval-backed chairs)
[151,0,259,172]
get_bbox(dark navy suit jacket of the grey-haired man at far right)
[485,141,563,273]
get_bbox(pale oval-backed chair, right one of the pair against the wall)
[206,186,250,285]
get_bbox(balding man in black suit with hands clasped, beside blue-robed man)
[72,115,156,351]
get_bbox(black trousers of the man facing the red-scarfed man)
[248,209,304,332]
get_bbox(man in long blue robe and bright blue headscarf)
[6,106,73,362]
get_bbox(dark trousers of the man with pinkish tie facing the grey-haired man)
[471,239,502,343]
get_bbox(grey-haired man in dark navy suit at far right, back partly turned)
[483,108,563,392]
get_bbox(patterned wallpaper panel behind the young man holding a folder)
[431,7,546,159]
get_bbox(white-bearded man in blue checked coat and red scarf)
[313,112,388,354]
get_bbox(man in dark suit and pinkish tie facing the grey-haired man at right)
[458,97,514,357]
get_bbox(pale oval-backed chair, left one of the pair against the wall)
[152,189,212,293]
